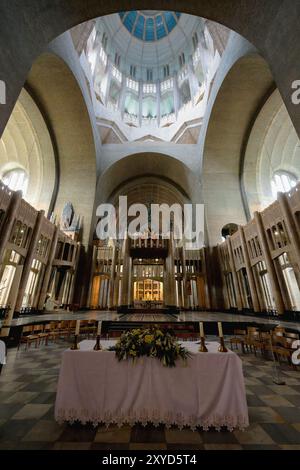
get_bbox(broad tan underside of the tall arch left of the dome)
[26,53,96,245]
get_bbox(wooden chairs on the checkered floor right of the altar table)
[229,327,299,365]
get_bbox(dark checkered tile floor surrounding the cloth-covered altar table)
[0,340,300,450]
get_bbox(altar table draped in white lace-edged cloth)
[55,340,249,431]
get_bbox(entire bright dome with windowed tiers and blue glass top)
[81,10,229,143]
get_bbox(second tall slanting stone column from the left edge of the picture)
[16,211,45,312]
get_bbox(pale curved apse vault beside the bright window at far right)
[243,90,300,215]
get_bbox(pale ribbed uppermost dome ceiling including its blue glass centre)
[97,10,204,68]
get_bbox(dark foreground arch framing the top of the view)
[0,0,300,142]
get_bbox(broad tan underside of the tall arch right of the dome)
[202,52,274,245]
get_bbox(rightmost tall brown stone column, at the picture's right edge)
[278,193,300,289]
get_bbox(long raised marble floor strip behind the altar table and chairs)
[0,310,300,332]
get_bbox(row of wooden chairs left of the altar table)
[18,320,97,349]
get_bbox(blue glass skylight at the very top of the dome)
[119,10,180,41]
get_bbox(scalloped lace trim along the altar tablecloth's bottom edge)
[55,408,249,431]
